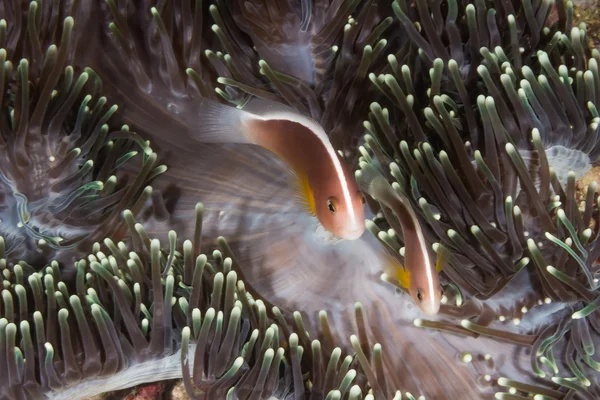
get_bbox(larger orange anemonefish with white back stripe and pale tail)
[191,98,365,240]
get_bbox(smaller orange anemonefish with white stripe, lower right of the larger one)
[360,165,450,315]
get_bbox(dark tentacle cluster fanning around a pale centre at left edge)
[0,1,165,269]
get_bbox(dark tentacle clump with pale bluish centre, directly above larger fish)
[212,0,404,154]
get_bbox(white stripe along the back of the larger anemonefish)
[254,110,359,229]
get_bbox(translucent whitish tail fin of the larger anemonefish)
[185,99,252,144]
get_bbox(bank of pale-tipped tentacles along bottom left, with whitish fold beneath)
[0,203,426,399]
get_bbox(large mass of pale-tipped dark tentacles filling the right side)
[357,1,600,398]
